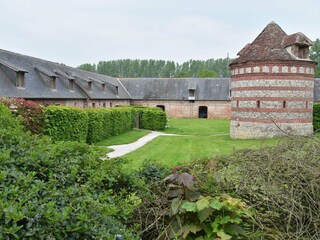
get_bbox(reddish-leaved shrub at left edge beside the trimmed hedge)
[0,98,44,134]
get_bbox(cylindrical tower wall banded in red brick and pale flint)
[230,61,314,138]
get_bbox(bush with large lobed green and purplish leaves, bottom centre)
[136,164,255,240]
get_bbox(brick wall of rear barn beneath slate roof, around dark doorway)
[132,100,231,119]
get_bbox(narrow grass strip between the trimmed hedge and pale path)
[96,129,150,146]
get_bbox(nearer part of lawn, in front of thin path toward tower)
[124,136,277,168]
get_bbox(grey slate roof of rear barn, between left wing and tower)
[120,78,230,100]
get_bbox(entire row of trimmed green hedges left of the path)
[44,106,167,144]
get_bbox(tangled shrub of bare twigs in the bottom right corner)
[223,137,320,239]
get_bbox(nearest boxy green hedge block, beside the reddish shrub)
[43,106,88,142]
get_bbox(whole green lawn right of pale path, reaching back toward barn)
[103,119,277,168]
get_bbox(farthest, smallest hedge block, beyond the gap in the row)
[134,107,167,131]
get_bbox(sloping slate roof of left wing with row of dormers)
[0,49,131,100]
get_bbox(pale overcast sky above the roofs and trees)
[0,0,320,67]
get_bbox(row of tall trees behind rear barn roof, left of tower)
[78,58,232,78]
